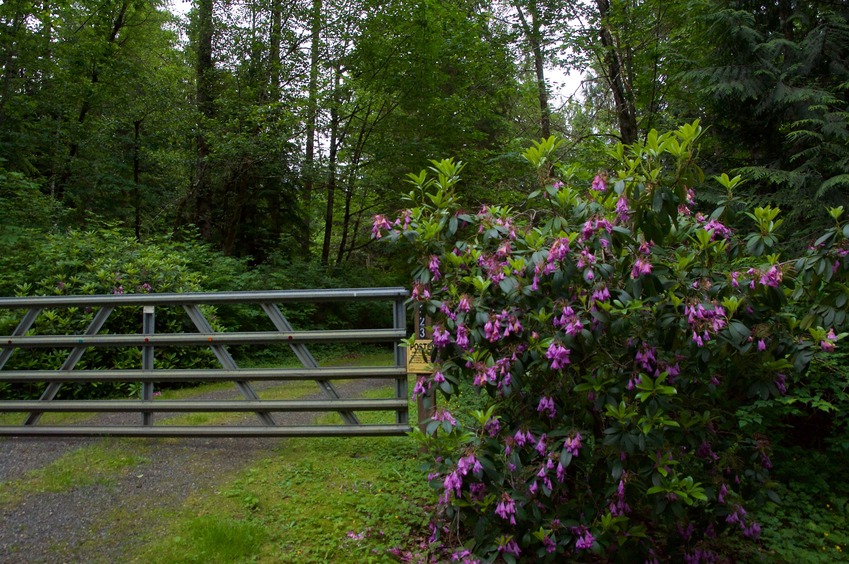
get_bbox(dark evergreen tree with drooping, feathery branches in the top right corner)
[687,0,849,225]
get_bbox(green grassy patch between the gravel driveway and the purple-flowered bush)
[137,388,433,562]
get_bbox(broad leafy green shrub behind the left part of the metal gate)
[0,226,222,398]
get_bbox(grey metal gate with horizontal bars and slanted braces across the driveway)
[0,288,410,437]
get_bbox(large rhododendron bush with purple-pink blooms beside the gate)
[374,122,849,562]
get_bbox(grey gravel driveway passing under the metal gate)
[0,380,387,563]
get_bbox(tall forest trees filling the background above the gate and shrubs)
[0,0,849,274]
